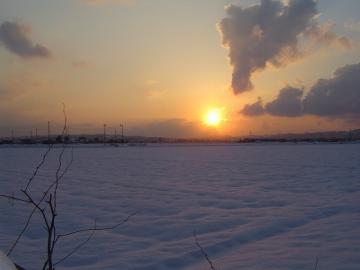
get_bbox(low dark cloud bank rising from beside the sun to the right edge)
[241,63,360,118]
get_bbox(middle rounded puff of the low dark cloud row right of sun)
[265,86,304,117]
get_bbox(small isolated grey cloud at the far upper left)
[0,21,51,59]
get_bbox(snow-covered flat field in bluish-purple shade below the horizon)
[0,144,360,270]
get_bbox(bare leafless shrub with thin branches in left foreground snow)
[0,104,135,270]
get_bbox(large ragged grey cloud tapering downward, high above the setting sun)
[218,0,348,94]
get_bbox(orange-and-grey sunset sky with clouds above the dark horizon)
[0,0,360,137]
